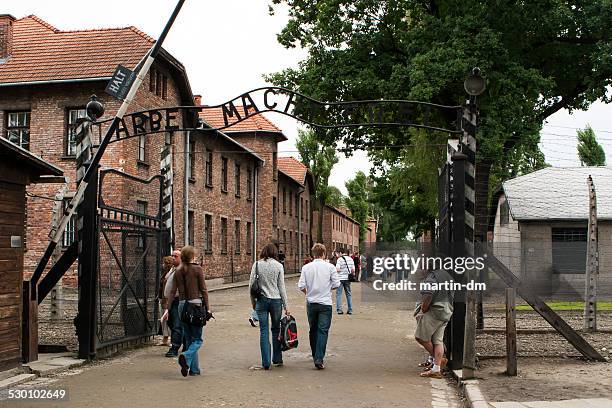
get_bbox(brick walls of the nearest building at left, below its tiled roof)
[0,63,180,286]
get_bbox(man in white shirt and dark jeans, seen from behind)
[298,244,340,370]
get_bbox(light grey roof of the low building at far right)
[502,167,612,221]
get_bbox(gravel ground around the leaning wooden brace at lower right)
[476,299,612,402]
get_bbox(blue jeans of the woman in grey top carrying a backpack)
[255,296,283,367]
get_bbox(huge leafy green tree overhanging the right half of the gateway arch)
[269,0,612,239]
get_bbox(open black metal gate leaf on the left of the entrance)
[95,169,169,350]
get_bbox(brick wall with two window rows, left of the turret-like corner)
[174,132,259,280]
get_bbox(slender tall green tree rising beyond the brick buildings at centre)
[295,130,338,242]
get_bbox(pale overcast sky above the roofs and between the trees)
[5,0,612,192]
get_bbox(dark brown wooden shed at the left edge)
[0,137,63,371]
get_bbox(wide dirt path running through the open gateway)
[9,280,458,408]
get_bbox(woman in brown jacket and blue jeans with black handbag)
[173,245,211,377]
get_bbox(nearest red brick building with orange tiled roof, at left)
[0,15,193,285]
